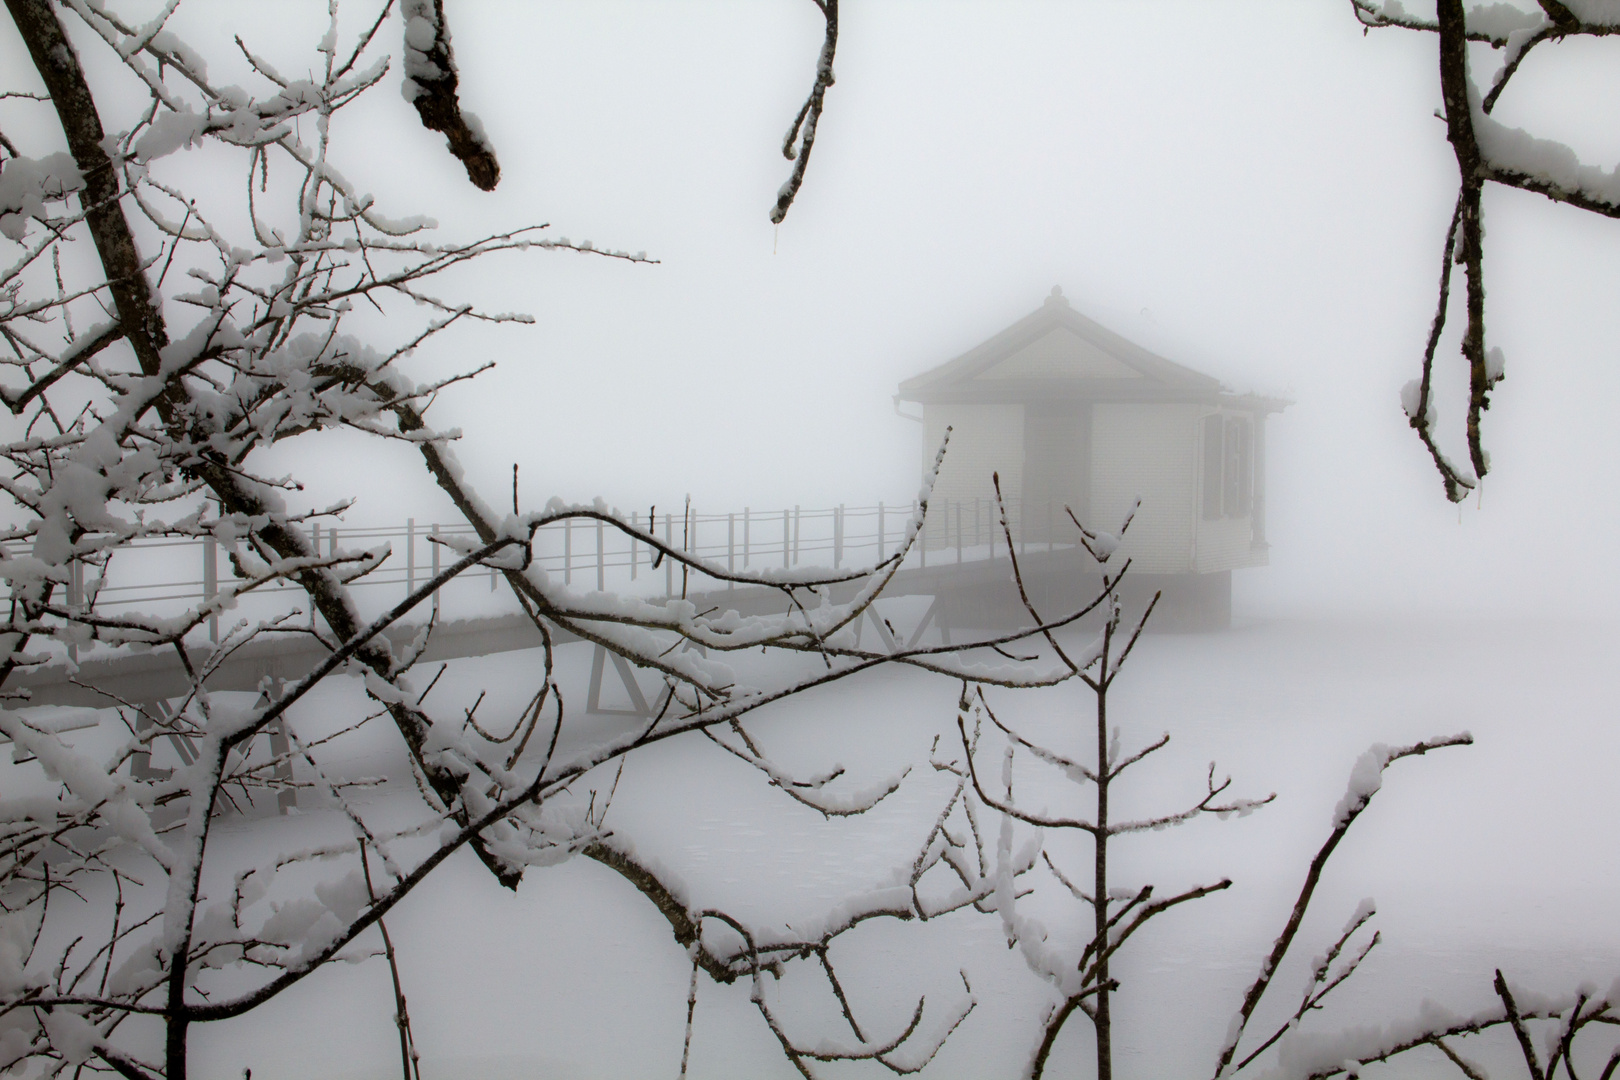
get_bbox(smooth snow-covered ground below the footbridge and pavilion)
[110,605,1620,1080]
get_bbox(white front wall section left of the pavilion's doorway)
[923,405,1024,547]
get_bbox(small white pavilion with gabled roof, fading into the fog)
[896,288,1288,628]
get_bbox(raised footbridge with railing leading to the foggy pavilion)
[8,499,1226,725]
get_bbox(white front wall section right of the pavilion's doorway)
[1092,403,1204,573]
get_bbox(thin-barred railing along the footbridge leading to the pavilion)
[15,497,1075,640]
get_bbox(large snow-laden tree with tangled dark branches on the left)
[0,0,1095,1080]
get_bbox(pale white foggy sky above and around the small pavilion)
[5,0,1620,617]
